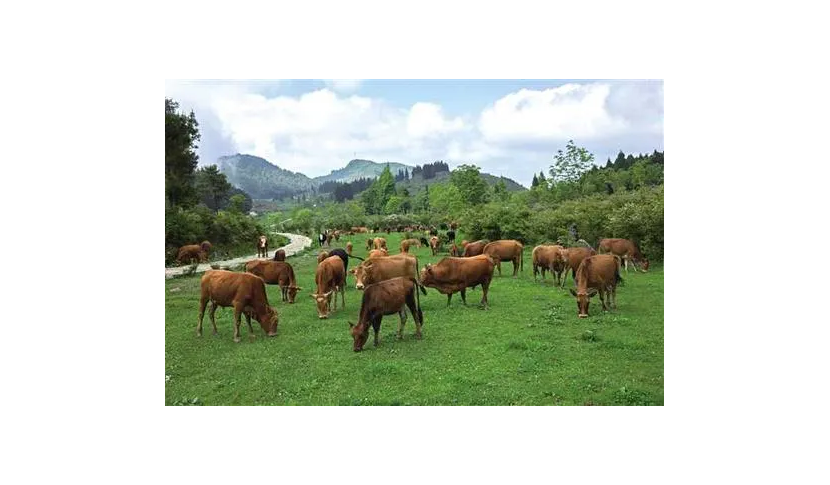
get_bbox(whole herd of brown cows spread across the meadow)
[185,227,649,352]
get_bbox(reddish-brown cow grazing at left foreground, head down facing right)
[196,270,279,342]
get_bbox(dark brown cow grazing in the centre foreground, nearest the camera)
[349,277,427,352]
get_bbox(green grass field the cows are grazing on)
[165,233,663,405]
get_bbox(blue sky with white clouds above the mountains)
[165,80,663,186]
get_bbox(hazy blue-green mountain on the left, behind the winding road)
[216,153,317,199]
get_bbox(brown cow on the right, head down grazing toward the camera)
[569,254,622,318]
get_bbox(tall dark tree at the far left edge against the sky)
[164,98,200,208]
